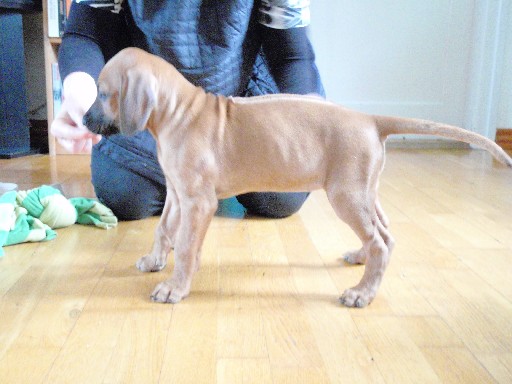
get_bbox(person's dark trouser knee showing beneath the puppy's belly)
[236,192,309,219]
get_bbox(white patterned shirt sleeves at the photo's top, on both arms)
[75,0,310,29]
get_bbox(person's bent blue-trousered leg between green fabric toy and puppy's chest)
[91,133,166,220]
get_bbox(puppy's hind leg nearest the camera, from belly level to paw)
[327,188,393,307]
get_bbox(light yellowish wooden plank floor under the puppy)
[0,149,512,384]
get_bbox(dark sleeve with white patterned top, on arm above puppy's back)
[258,0,325,96]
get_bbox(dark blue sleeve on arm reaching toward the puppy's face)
[58,1,128,80]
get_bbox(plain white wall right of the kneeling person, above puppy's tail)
[310,0,512,136]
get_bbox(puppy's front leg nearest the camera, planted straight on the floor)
[151,194,217,303]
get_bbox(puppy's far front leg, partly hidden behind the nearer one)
[136,182,180,272]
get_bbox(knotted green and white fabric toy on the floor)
[0,185,117,256]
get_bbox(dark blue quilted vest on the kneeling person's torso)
[127,0,277,95]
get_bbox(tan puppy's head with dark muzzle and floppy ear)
[83,49,157,136]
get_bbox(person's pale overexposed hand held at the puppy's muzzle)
[50,72,101,153]
